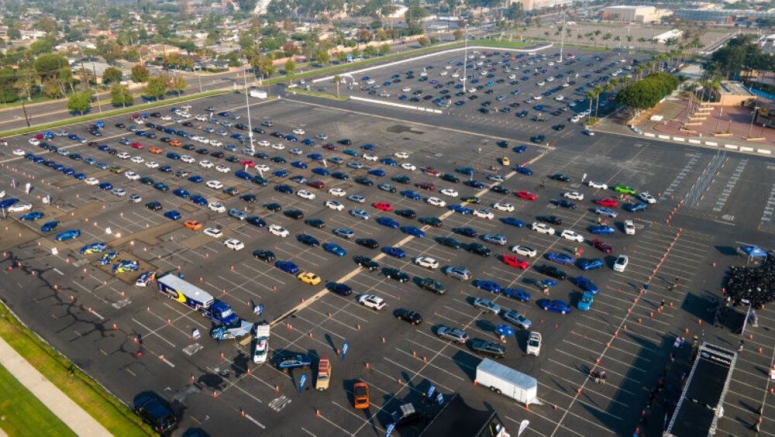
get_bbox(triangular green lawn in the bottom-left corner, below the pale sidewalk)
[0,366,76,436]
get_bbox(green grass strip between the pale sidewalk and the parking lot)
[0,305,154,437]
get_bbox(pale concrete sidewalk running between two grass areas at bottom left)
[0,338,111,437]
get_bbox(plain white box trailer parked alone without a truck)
[475,358,541,405]
